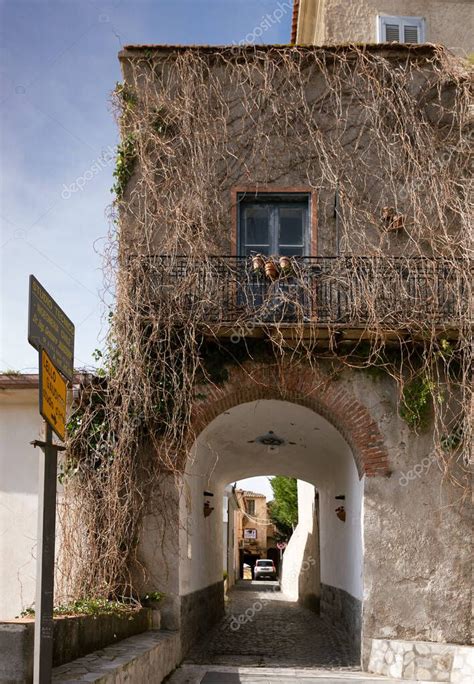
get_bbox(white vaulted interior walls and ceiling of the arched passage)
[179,399,363,664]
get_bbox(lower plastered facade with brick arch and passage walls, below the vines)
[138,360,470,668]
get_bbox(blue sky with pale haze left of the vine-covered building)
[0,0,291,372]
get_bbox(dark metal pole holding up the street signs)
[31,422,64,684]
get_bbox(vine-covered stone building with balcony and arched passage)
[111,38,470,679]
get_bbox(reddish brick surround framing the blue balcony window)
[231,186,317,257]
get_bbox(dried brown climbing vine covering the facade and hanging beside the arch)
[61,46,473,597]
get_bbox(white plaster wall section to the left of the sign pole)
[0,389,41,620]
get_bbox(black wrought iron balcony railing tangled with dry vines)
[132,256,470,327]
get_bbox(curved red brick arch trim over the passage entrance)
[191,362,390,477]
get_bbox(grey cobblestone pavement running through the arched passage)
[185,582,357,669]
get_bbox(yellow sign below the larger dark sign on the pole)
[40,349,66,442]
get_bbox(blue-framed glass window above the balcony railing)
[238,193,309,256]
